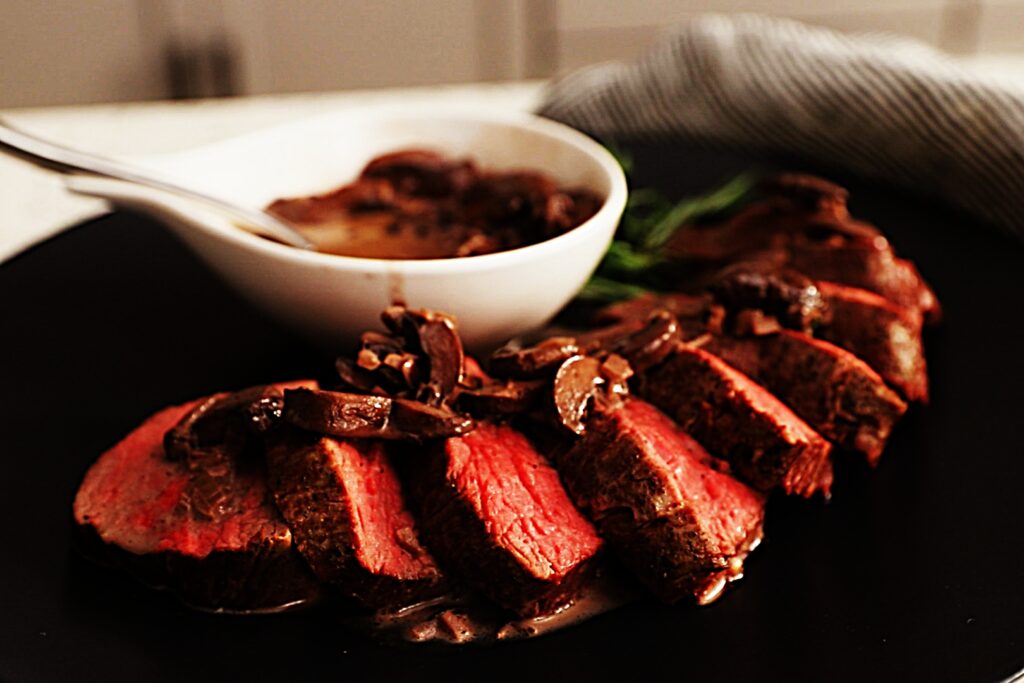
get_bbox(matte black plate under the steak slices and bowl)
[0,145,1024,682]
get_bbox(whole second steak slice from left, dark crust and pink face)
[266,432,444,608]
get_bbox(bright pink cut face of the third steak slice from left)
[445,423,601,582]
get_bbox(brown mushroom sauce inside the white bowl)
[267,150,603,259]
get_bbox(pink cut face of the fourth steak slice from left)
[615,398,764,555]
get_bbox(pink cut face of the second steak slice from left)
[323,438,437,581]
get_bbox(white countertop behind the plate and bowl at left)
[0,81,544,263]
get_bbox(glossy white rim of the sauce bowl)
[172,104,628,275]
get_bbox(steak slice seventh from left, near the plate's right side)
[816,282,928,402]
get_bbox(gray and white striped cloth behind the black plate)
[540,14,1024,237]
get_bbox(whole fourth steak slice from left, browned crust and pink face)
[558,398,764,604]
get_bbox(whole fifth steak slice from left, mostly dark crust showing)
[640,347,833,498]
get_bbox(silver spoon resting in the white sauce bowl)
[0,119,315,249]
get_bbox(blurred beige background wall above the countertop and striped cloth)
[0,0,1024,109]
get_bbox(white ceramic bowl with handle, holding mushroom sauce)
[69,106,627,349]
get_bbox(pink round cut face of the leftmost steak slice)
[74,401,291,558]
